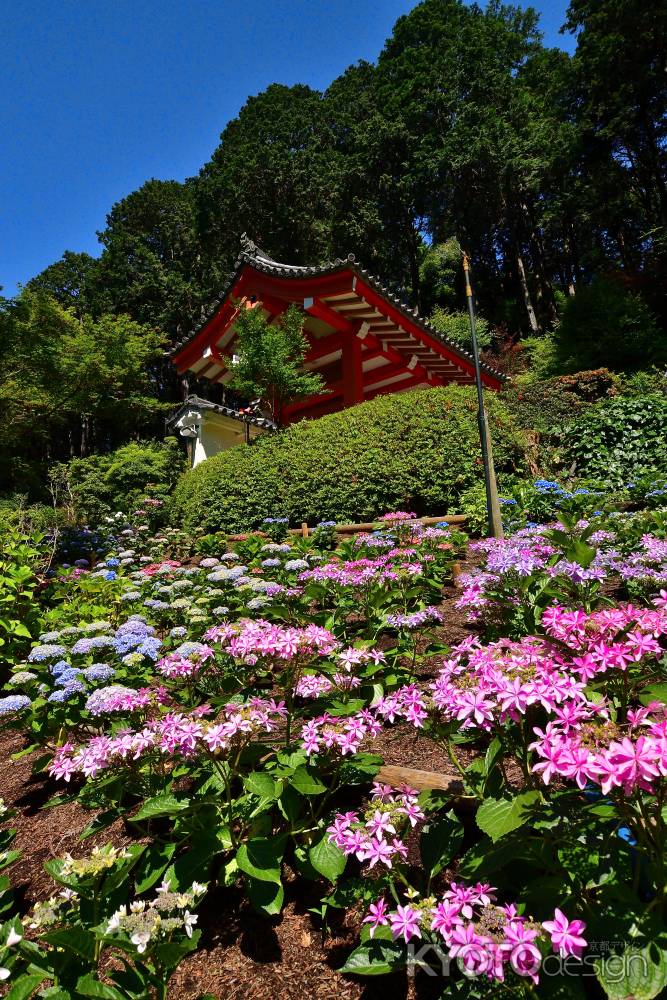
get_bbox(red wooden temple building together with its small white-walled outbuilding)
[171,237,503,464]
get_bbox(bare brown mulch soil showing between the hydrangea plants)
[0,560,486,1000]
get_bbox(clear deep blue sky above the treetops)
[0,0,572,295]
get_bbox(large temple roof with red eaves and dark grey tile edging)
[172,234,505,389]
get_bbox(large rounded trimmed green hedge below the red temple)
[169,386,525,531]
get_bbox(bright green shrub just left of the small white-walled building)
[54,438,185,521]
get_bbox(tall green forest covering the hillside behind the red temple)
[0,0,667,498]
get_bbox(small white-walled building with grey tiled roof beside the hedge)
[172,396,277,467]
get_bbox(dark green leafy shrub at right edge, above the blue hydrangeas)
[562,393,667,485]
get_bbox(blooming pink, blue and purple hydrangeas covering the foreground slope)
[0,496,667,1000]
